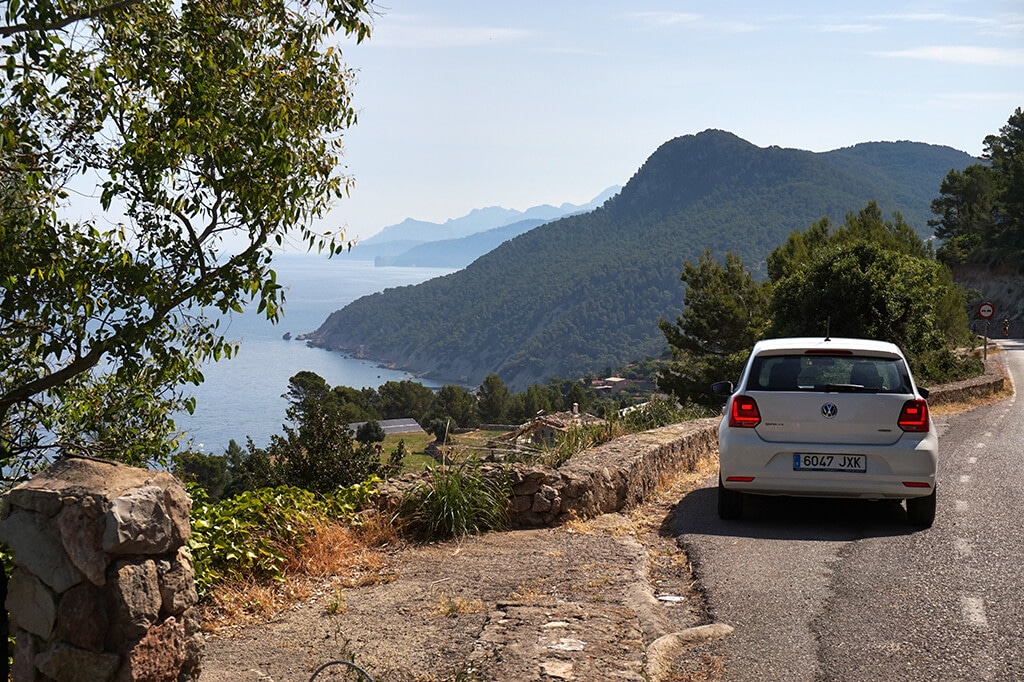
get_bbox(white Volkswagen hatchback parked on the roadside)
[712,338,938,526]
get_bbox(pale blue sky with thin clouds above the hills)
[327,0,1024,239]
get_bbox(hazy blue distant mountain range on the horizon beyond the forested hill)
[349,185,622,268]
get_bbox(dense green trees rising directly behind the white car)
[658,202,976,403]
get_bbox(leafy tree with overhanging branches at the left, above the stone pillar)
[0,0,371,473]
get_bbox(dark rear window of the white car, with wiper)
[748,354,910,393]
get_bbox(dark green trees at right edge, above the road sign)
[928,108,1024,265]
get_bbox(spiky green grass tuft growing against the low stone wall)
[398,460,511,540]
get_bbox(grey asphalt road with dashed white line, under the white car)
[673,340,1024,682]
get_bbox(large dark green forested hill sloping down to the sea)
[307,130,976,389]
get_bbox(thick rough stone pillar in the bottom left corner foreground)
[0,458,203,682]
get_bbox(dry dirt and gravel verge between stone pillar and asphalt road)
[202,458,722,682]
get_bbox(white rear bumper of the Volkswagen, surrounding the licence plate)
[719,427,938,500]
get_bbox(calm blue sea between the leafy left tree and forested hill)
[175,253,454,455]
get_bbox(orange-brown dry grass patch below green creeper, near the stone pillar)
[200,516,399,632]
